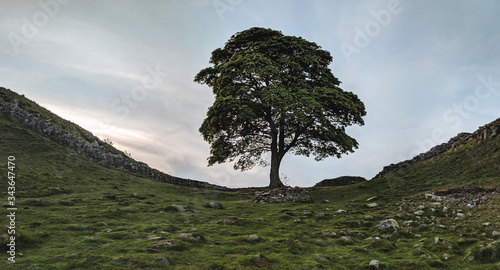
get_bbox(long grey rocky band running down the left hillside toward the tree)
[0,93,236,191]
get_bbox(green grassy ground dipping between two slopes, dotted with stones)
[0,88,500,269]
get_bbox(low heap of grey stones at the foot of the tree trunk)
[254,187,312,203]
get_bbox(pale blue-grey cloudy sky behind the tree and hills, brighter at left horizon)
[0,0,500,187]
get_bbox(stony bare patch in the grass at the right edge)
[434,187,500,207]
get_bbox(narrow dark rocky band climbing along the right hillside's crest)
[372,132,471,180]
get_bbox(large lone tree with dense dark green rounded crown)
[194,28,366,188]
